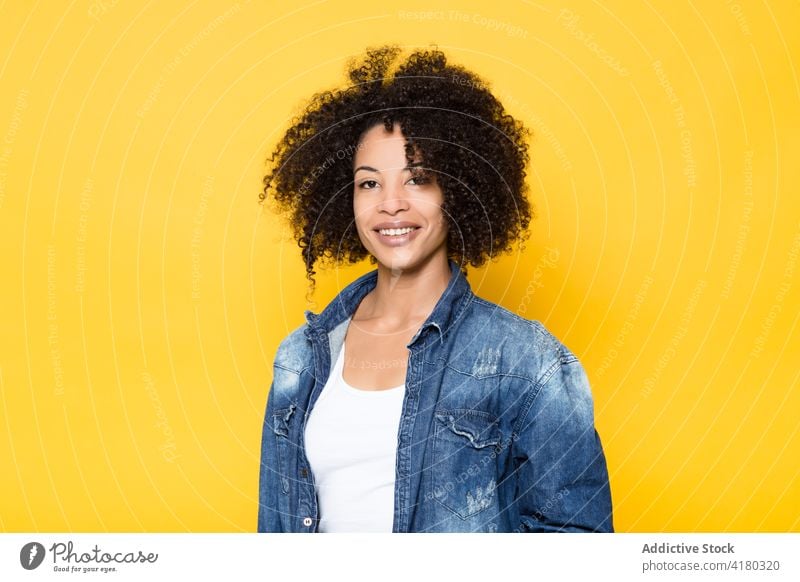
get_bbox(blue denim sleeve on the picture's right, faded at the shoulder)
[512,354,614,532]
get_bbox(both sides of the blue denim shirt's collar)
[305,259,472,341]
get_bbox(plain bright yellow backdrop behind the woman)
[0,0,800,532]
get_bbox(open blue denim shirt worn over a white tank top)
[258,260,613,532]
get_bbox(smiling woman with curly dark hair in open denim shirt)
[258,46,613,532]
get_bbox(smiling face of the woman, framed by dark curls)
[353,124,447,270]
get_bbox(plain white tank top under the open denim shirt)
[305,344,405,532]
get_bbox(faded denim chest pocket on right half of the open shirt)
[430,409,502,519]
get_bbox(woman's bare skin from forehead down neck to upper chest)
[342,125,450,390]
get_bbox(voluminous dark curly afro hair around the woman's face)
[259,45,532,289]
